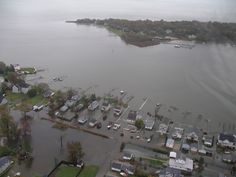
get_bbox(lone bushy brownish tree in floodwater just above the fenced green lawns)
[67,141,84,163]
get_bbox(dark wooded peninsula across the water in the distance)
[66,18,236,47]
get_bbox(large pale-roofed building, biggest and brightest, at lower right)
[169,157,193,174]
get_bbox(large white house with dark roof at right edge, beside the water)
[217,133,236,149]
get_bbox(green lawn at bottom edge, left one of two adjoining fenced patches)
[55,165,80,177]
